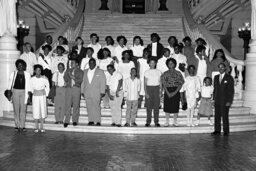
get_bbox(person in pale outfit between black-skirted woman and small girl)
[183,65,201,126]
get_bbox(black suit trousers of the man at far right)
[214,104,229,133]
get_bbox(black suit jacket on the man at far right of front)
[213,74,234,105]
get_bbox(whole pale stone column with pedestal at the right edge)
[243,0,256,114]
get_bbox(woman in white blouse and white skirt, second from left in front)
[31,65,50,133]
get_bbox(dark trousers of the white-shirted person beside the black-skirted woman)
[146,86,160,124]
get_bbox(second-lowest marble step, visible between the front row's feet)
[4,112,256,125]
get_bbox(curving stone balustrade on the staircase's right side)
[182,0,244,99]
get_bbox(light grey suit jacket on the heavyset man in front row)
[81,68,106,99]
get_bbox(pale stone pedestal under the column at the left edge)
[0,36,20,117]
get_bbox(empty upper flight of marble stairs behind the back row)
[82,13,184,46]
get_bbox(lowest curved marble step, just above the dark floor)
[0,118,256,134]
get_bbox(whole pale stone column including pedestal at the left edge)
[0,0,20,117]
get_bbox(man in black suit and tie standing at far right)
[212,63,234,136]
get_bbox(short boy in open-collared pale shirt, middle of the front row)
[124,68,141,126]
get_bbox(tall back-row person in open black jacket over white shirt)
[147,33,164,60]
